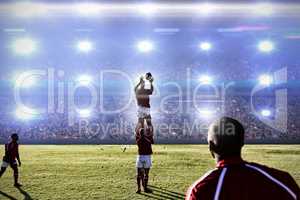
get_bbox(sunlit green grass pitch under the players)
[0,145,300,200]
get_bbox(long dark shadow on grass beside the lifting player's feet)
[142,185,185,200]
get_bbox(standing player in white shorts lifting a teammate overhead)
[136,126,154,194]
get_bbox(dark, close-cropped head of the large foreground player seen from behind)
[207,117,245,158]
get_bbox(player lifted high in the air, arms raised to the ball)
[134,72,154,129]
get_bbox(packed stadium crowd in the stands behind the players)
[0,92,300,143]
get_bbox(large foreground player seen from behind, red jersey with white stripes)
[186,117,300,200]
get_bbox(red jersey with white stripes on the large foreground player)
[186,158,300,200]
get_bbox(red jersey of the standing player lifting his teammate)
[135,129,154,155]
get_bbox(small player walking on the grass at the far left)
[0,133,22,187]
